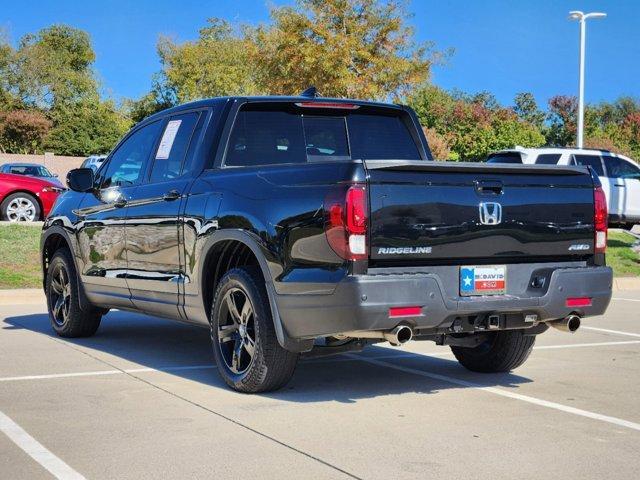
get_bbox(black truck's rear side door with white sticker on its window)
[125,111,202,317]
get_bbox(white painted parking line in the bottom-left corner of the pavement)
[0,412,85,480]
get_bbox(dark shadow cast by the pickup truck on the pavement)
[3,311,531,403]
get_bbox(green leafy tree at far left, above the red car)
[0,25,130,155]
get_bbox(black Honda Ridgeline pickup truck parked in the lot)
[41,95,612,392]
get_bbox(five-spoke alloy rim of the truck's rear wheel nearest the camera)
[217,288,256,374]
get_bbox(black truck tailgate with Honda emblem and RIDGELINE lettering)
[365,160,594,265]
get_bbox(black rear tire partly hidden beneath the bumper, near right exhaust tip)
[451,330,536,373]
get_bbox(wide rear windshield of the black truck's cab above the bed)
[224,104,421,166]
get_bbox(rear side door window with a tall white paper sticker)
[150,112,200,183]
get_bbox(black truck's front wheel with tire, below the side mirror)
[45,248,103,338]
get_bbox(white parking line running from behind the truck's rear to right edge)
[347,353,640,431]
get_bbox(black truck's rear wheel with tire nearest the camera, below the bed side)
[210,267,298,393]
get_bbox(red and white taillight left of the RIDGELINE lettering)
[325,184,367,260]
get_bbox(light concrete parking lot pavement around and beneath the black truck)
[0,291,640,479]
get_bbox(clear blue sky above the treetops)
[0,0,640,107]
